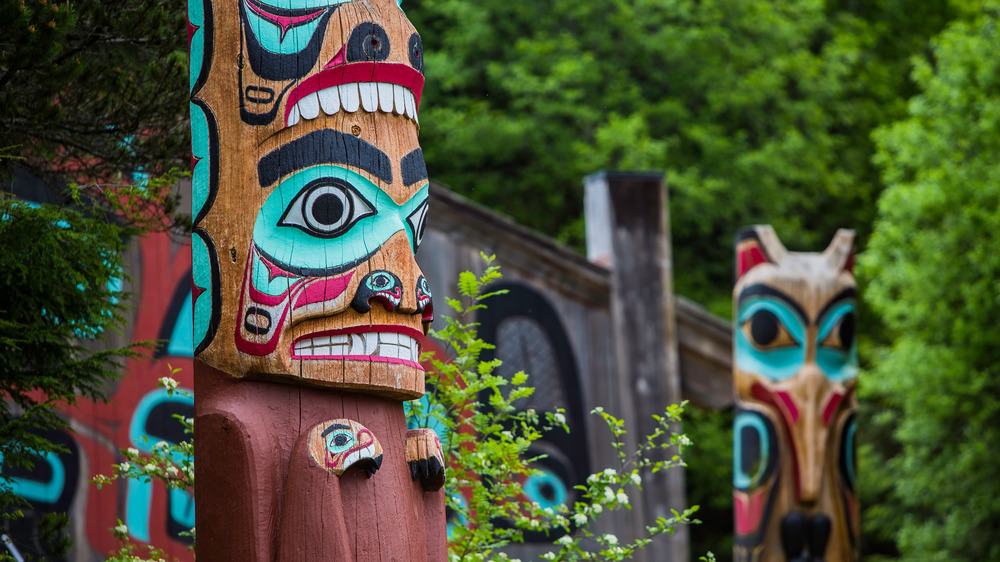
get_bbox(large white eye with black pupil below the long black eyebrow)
[278,178,376,238]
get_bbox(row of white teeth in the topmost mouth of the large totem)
[285,82,420,127]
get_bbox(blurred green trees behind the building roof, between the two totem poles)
[406,0,955,316]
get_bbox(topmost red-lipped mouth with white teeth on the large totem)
[285,62,424,127]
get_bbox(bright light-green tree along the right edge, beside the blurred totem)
[860,0,1000,560]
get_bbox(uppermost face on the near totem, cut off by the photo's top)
[237,0,424,135]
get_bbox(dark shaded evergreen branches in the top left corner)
[0,0,189,184]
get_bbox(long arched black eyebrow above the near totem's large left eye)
[257,129,392,187]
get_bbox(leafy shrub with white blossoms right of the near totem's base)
[414,256,697,560]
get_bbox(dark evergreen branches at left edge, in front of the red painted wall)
[0,199,150,516]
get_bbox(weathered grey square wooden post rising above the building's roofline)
[584,172,688,560]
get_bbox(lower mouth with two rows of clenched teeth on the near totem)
[292,325,424,371]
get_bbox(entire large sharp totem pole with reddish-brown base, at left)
[188,0,447,561]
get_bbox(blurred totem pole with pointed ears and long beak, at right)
[733,226,860,562]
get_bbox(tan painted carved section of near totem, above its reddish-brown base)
[191,0,431,398]
